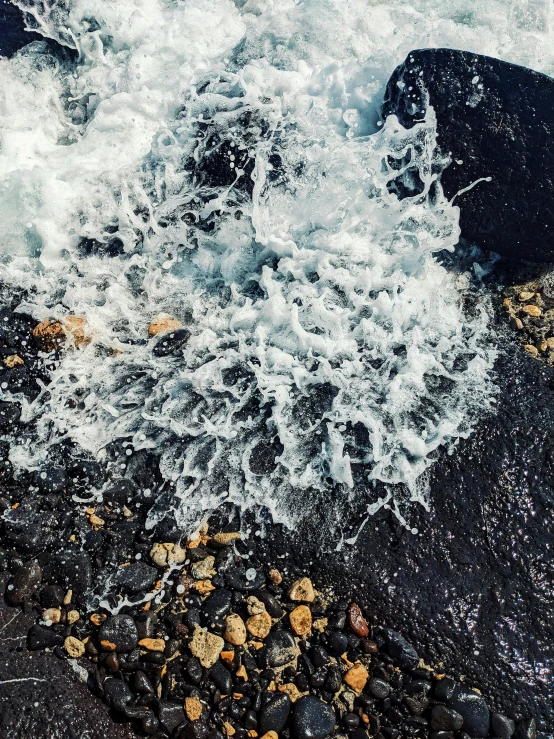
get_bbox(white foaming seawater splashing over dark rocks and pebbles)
[0,0,554,527]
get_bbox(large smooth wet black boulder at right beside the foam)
[383,49,554,262]
